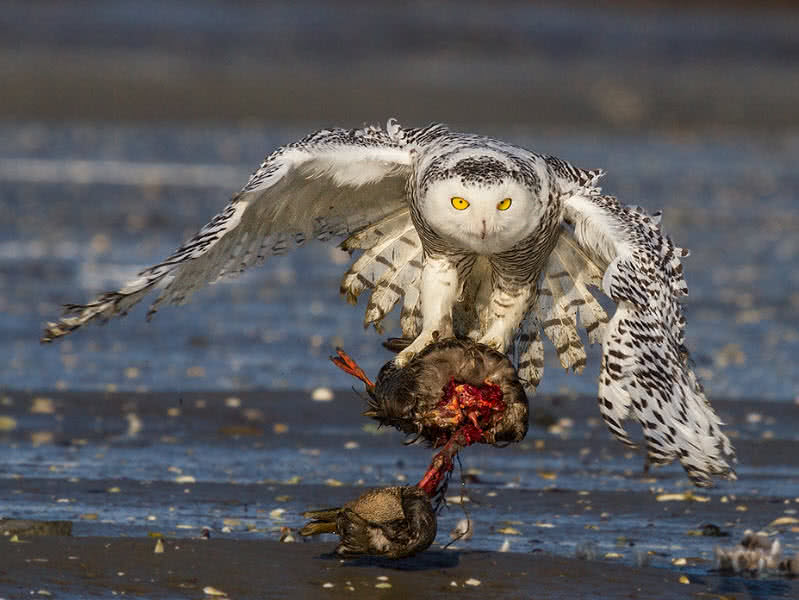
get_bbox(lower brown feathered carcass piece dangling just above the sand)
[300,486,436,558]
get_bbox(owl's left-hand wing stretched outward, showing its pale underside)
[42,120,418,342]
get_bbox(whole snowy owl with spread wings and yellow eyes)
[42,119,735,485]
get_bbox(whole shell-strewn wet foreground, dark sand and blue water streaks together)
[0,391,799,598]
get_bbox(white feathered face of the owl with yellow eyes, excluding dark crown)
[421,179,544,255]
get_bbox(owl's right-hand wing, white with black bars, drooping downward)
[561,192,735,486]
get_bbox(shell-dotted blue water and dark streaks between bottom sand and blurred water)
[0,391,799,589]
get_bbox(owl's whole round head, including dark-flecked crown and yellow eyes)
[420,156,544,255]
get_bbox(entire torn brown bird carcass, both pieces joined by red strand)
[300,338,528,558]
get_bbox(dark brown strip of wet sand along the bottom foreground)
[0,537,748,600]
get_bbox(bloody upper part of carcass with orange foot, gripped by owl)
[332,338,528,496]
